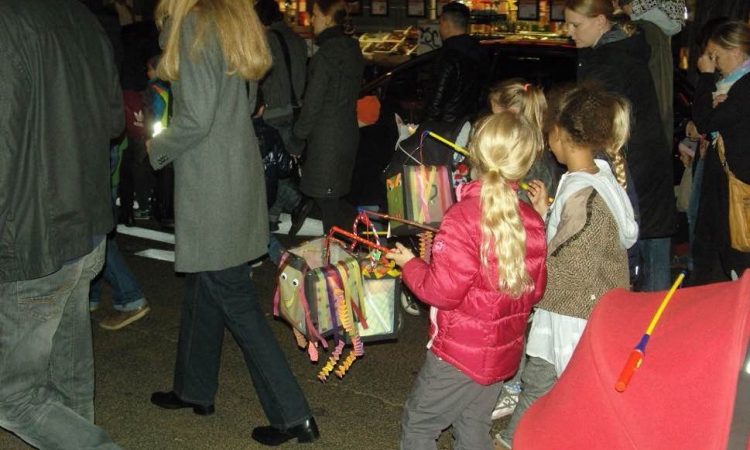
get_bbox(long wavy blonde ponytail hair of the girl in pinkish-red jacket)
[469,111,542,298]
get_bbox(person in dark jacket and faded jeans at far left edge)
[0,0,124,449]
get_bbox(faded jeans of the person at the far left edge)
[0,242,119,450]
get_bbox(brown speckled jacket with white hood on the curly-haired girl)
[538,160,638,319]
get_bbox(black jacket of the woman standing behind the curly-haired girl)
[578,26,677,239]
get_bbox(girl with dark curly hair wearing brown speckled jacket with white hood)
[498,85,638,447]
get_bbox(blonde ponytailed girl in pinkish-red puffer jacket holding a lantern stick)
[386,112,546,450]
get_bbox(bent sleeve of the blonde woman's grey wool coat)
[149,21,224,169]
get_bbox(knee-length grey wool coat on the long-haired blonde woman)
[149,15,268,272]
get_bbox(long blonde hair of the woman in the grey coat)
[155,0,271,81]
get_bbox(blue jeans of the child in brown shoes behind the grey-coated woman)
[89,237,146,311]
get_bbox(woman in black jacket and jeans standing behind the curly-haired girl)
[565,0,677,291]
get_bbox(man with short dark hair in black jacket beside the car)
[426,2,482,122]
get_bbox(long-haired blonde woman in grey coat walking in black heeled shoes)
[149,0,319,445]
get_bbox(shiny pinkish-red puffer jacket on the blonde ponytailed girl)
[403,181,547,385]
